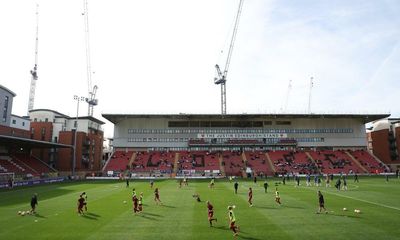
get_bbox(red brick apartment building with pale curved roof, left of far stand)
[29,109,104,172]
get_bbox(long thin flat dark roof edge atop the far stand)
[102,113,390,124]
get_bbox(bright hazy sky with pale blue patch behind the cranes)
[0,0,400,136]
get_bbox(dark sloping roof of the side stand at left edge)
[0,135,73,148]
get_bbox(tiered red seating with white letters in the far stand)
[103,150,385,176]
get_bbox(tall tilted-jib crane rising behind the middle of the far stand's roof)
[214,0,243,115]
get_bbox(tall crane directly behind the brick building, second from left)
[82,0,98,116]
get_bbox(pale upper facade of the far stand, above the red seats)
[110,117,367,148]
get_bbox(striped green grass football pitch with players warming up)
[0,177,400,240]
